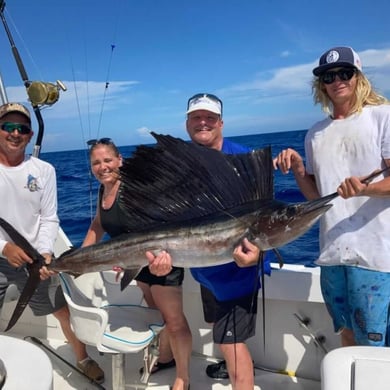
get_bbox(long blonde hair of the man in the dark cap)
[312,70,390,115]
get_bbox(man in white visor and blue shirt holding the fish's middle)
[148,93,270,390]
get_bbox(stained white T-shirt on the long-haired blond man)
[305,105,390,272]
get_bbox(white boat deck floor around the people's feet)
[29,338,321,390]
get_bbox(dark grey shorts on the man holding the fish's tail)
[0,258,66,316]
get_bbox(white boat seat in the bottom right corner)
[321,346,390,390]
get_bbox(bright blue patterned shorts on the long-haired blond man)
[321,265,390,346]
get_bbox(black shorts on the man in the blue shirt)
[201,286,258,344]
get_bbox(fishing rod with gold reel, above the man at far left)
[0,0,66,157]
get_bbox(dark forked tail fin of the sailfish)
[0,218,45,331]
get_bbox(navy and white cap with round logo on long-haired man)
[313,46,362,76]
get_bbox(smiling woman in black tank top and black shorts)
[83,138,192,389]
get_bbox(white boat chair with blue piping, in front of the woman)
[60,271,164,390]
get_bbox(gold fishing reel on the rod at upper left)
[26,80,66,106]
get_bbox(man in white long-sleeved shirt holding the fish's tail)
[0,103,104,383]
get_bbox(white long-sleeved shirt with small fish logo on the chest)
[0,156,59,254]
